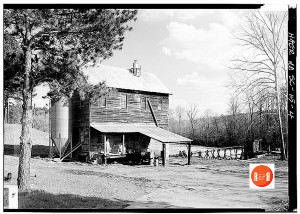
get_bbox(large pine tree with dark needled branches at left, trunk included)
[4,9,137,190]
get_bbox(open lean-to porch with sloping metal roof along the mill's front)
[90,123,192,166]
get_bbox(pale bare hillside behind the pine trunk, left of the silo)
[4,124,49,146]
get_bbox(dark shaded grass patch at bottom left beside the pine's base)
[19,190,128,209]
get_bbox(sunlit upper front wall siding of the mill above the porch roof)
[90,90,169,128]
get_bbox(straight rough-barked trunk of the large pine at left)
[18,47,32,190]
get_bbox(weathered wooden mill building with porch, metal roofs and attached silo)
[51,61,192,163]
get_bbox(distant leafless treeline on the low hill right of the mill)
[169,103,287,150]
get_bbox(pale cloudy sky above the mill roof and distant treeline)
[34,6,288,115]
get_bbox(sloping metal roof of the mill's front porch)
[91,123,192,143]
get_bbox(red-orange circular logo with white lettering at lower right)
[251,165,273,187]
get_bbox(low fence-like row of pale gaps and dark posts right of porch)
[197,146,244,160]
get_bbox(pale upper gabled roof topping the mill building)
[83,64,171,94]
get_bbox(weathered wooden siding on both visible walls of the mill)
[72,90,169,156]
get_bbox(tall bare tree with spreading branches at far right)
[230,11,287,159]
